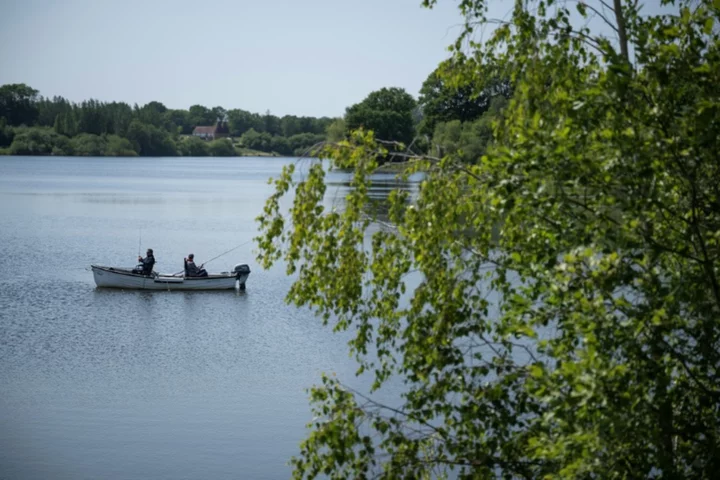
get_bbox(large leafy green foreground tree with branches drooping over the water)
[258,0,720,479]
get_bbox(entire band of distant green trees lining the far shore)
[0,68,513,163]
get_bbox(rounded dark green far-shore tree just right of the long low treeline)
[345,87,415,143]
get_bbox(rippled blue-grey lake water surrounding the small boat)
[0,157,420,480]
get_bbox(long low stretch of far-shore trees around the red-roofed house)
[0,84,333,156]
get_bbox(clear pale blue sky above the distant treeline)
[0,0,478,117]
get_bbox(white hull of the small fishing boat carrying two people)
[91,265,250,290]
